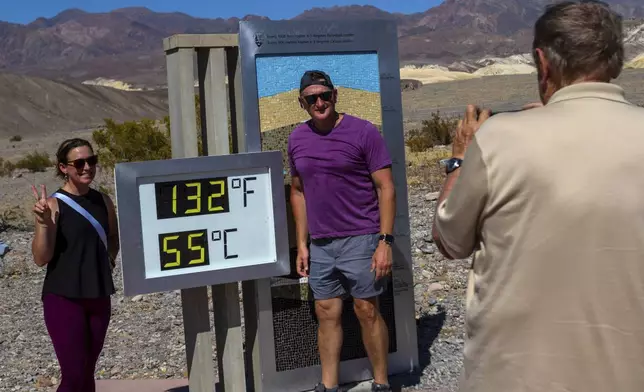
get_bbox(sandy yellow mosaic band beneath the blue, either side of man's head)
[259,87,382,132]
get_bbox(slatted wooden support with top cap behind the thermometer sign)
[163,34,253,392]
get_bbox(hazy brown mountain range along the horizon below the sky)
[0,0,644,85]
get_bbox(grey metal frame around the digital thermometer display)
[114,151,290,296]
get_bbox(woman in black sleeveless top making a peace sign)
[32,139,119,392]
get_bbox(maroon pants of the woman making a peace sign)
[43,294,112,392]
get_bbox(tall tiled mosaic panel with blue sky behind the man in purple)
[256,53,396,371]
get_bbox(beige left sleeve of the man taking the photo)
[435,137,488,259]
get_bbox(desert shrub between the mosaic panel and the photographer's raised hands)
[406,111,458,152]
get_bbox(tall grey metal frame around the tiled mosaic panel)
[239,20,418,392]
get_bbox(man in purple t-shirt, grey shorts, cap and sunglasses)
[288,71,395,392]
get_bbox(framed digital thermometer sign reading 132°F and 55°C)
[115,151,289,295]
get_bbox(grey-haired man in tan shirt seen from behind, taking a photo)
[433,2,644,392]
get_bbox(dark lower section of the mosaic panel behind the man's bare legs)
[271,264,396,372]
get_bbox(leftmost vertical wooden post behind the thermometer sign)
[166,48,215,392]
